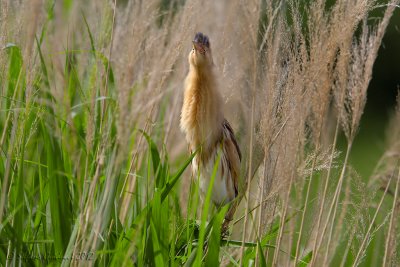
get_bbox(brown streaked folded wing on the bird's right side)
[222,120,242,196]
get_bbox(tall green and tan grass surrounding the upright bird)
[0,0,400,266]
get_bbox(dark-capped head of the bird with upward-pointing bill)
[189,32,213,68]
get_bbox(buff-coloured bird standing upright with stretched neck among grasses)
[180,32,242,231]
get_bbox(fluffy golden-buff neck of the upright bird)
[181,66,224,155]
